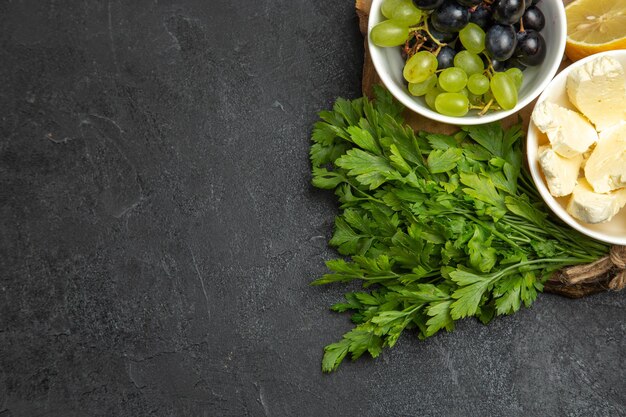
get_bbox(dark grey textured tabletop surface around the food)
[0,0,626,417]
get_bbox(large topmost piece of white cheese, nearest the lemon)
[566,56,626,131]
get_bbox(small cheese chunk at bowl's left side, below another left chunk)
[537,146,583,197]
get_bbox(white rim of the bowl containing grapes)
[367,0,567,126]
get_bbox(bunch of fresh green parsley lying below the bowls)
[310,88,609,372]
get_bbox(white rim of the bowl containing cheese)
[526,49,626,245]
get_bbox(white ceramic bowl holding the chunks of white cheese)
[526,50,626,245]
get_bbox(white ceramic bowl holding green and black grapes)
[367,0,567,125]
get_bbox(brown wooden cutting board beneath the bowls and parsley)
[356,0,626,298]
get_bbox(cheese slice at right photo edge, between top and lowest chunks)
[585,123,626,193]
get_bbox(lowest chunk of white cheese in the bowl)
[567,178,626,224]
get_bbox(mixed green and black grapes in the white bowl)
[370,0,546,117]
